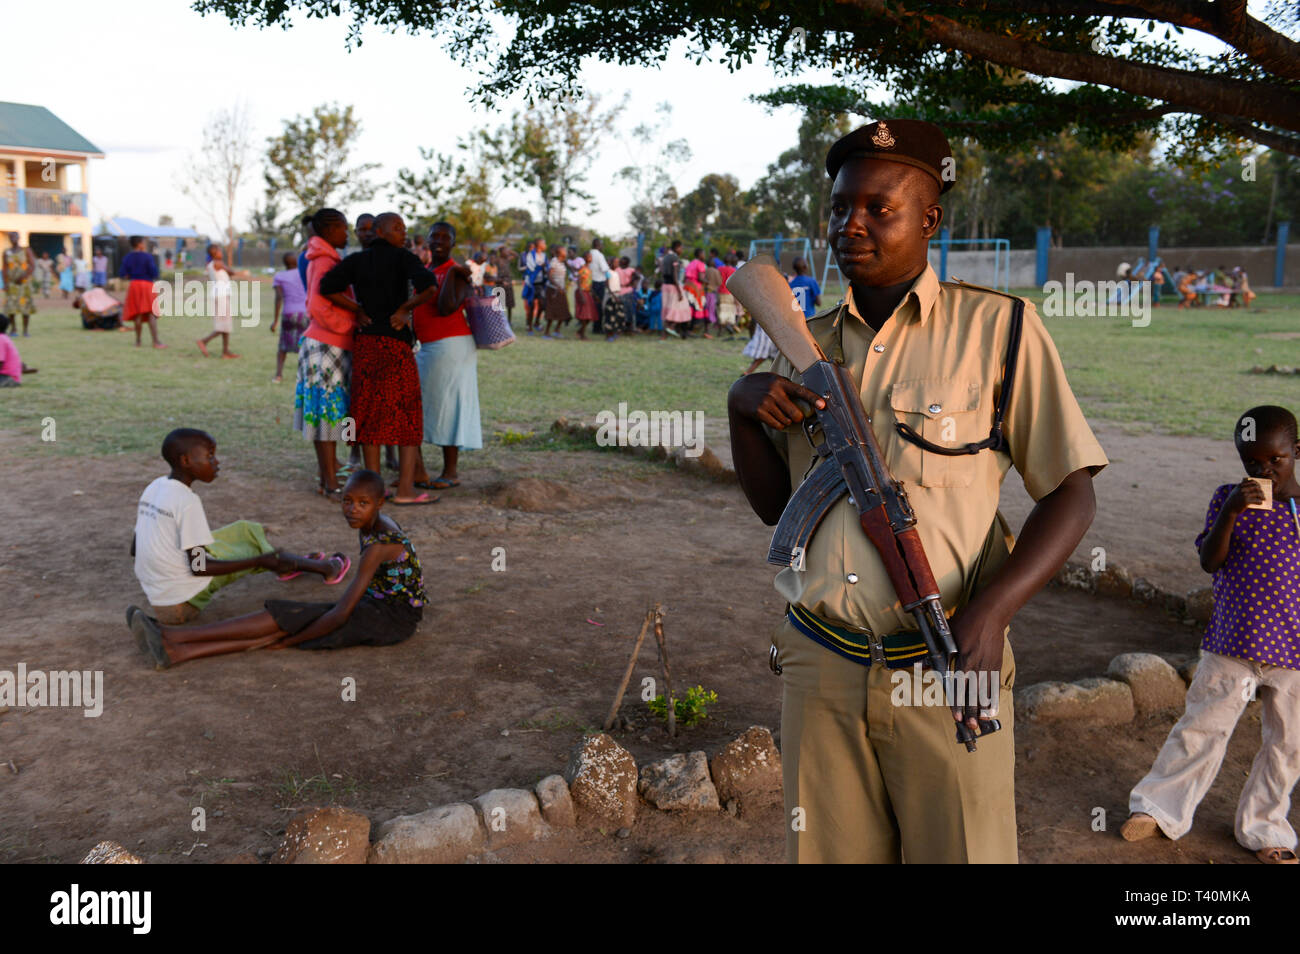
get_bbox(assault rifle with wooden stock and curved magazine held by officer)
[727,259,1002,751]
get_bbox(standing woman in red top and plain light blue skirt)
[412,222,484,490]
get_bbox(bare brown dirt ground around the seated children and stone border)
[0,434,1297,863]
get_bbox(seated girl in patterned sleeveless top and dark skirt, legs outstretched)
[126,471,425,669]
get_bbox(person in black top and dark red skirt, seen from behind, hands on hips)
[320,212,438,507]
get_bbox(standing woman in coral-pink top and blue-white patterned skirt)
[294,209,356,496]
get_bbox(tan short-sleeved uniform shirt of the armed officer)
[764,265,1108,634]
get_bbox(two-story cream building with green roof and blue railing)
[0,103,104,263]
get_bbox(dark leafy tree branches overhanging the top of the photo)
[194,0,1300,155]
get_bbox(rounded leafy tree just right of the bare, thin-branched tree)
[265,104,378,212]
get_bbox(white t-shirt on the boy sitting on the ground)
[135,477,212,606]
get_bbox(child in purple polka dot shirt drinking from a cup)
[1121,404,1300,864]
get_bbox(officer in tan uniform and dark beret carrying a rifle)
[728,120,1106,863]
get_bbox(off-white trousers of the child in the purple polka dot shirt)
[1128,652,1300,851]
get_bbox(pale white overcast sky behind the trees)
[0,0,1237,235]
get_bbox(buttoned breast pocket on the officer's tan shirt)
[889,378,988,487]
